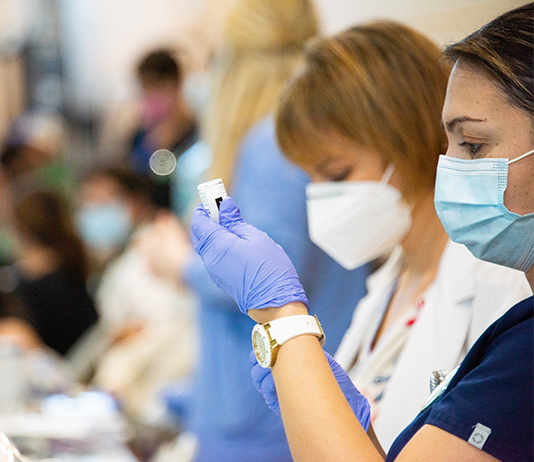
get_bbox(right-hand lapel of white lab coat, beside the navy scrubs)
[373,242,476,450]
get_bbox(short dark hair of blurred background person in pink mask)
[137,49,182,85]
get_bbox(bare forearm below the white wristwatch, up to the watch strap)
[272,335,383,462]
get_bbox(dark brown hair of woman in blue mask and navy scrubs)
[444,3,534,114]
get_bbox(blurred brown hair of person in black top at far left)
[14,190,88,281]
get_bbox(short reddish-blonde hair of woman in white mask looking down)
[276,21,447,197]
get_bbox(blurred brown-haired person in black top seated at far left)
[7,191,98,355]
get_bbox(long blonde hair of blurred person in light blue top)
[204,0,318,186]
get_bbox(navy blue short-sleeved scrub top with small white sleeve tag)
[386,297,534,461]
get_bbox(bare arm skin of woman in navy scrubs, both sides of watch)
[255,303,497,462]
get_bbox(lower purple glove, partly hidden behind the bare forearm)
[249,351,371,431]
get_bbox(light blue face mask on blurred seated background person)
[76,201,132,251]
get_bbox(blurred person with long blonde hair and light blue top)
[144,0,369,462]
